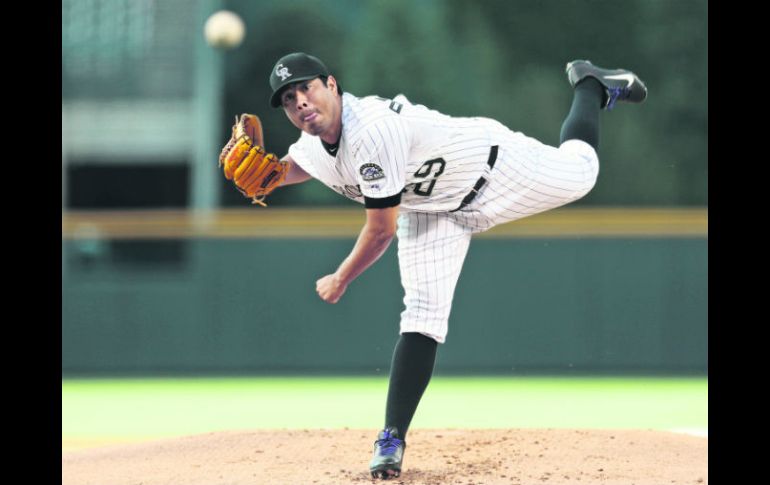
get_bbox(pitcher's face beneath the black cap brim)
[281,76,342,143]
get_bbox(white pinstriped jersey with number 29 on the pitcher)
[289,93,507,212]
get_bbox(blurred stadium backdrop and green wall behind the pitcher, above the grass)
[62,0,708,378]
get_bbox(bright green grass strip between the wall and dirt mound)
[62,376,708,451]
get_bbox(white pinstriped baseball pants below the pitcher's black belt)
[397,132,599,343]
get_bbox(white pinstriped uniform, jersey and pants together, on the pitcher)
[289,93,599,343]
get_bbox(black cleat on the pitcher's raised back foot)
[567,60,647,110]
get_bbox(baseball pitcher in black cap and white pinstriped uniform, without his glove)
[224,52,647,479]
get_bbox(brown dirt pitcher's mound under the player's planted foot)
[62,429,708,485]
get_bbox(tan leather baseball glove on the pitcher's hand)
[219,113,289,206]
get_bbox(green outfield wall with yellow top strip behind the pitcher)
[62,210,708,376]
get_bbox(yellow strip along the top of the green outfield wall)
[62,207,708,239]
